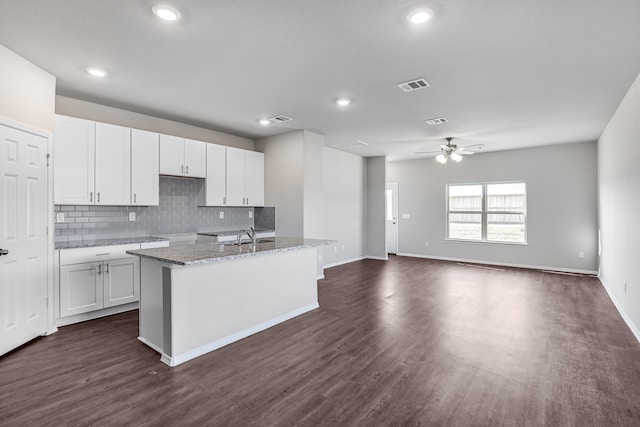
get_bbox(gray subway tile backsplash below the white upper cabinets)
[55,177,275,242]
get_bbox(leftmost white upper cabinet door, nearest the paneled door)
[53,116,95,205]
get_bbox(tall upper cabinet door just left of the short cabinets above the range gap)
[131,129,160,206]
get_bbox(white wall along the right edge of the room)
[598,72,640,340]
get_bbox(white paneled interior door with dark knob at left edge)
[0,125,47,355]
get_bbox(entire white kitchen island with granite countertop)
[127,237,335,366]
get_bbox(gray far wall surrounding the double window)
[387,142,598,272]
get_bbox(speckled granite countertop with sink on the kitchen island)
[127,236,336,265]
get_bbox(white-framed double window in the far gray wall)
[447,182,527,243]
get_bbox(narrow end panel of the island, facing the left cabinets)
[138,257,164,353]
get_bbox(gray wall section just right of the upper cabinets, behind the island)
[256,131,304,237]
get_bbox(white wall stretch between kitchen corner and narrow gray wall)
[323,147,365,266]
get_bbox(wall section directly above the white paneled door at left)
[0,45,56,133]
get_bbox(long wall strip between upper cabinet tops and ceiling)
[55,96,254,150]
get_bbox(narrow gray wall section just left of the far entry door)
[365,157,387,259]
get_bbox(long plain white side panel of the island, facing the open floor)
[164,248,318,365]
